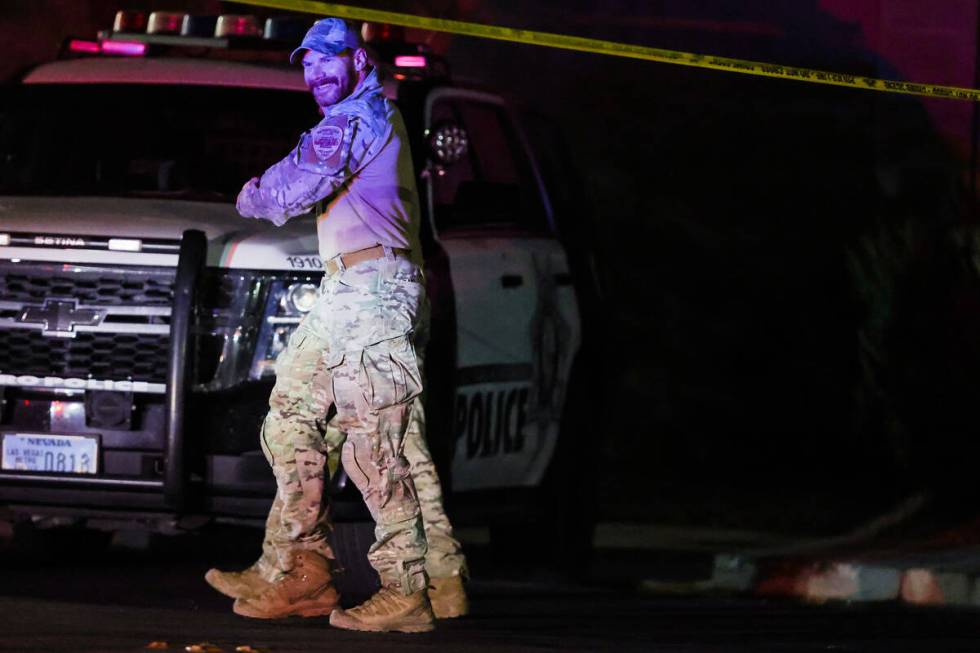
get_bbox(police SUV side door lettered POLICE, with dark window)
[426,89,579,491]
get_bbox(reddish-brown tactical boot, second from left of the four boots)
[232,551,339,619]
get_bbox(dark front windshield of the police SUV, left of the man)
[0,84,320,202]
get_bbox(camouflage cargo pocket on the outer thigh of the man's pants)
[358,336,422,410]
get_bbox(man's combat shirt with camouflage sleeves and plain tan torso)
[237,71,419,260]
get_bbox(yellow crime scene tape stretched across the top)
[233,0,980,101]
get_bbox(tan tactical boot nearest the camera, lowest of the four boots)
[330,587,435,633]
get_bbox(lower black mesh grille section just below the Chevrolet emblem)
[0,329,169,383]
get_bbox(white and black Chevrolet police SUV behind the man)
[0,12,594,584]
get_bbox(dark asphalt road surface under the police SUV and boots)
[0,529,980,653]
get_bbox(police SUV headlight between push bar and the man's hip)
[249,281,317,379]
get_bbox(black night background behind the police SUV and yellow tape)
[0,0,980,533]
